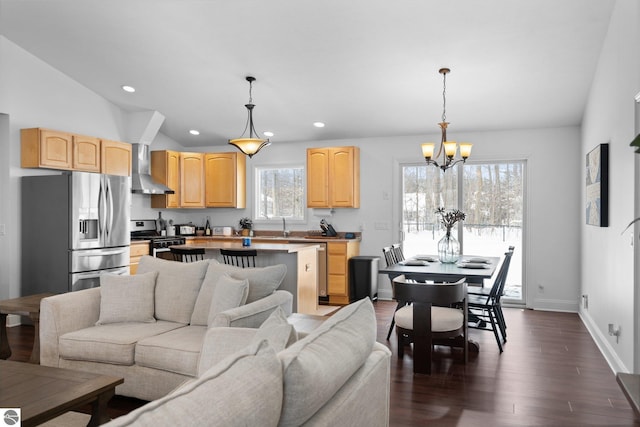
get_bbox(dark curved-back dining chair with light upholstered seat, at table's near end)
[393,275,469,374]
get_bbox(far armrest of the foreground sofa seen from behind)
[198,328,257,377]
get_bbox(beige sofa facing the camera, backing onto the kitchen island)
[40,256,293,400]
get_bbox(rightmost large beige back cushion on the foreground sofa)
[278,298,376,426]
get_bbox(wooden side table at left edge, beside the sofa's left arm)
[0,293,55,364]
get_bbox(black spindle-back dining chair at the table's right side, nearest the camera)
[468,246,515,353]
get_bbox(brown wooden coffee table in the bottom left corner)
[0,360,124,427]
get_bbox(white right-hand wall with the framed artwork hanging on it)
[580,0,640,372]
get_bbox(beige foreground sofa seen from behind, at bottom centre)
[107,298,391,427]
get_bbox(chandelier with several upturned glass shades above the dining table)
[422,68,473,171]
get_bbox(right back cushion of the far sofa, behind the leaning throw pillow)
[191,260,287,325]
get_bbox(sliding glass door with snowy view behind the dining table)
[402,161,526,303]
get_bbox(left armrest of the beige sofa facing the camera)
[40,288,100,367]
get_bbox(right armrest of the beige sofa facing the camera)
[209,290,293,328]
